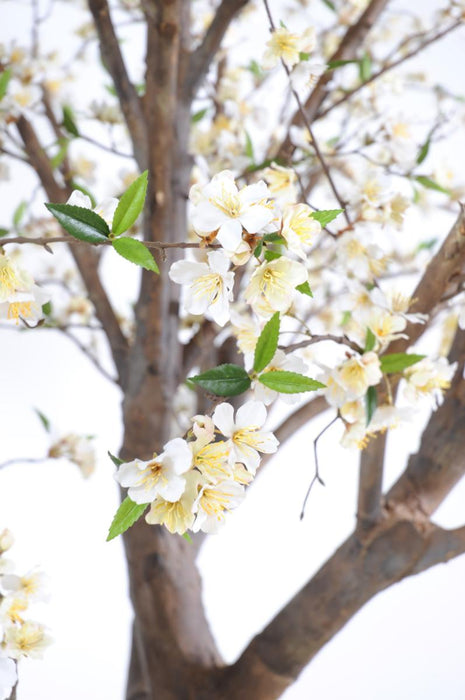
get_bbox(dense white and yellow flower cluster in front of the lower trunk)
[115,401,278,534]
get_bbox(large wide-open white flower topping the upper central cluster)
[191,170,275,253]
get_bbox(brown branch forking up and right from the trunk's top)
[184,0,249,96]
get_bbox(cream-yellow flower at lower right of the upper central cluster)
[245,257,308,313]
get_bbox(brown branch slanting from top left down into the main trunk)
[88,0,147,170]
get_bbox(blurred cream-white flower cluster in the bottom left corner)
[0,530,51,700]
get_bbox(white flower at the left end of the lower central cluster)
[115,438,192,503]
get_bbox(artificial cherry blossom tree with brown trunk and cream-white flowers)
[0,0,465,700]
